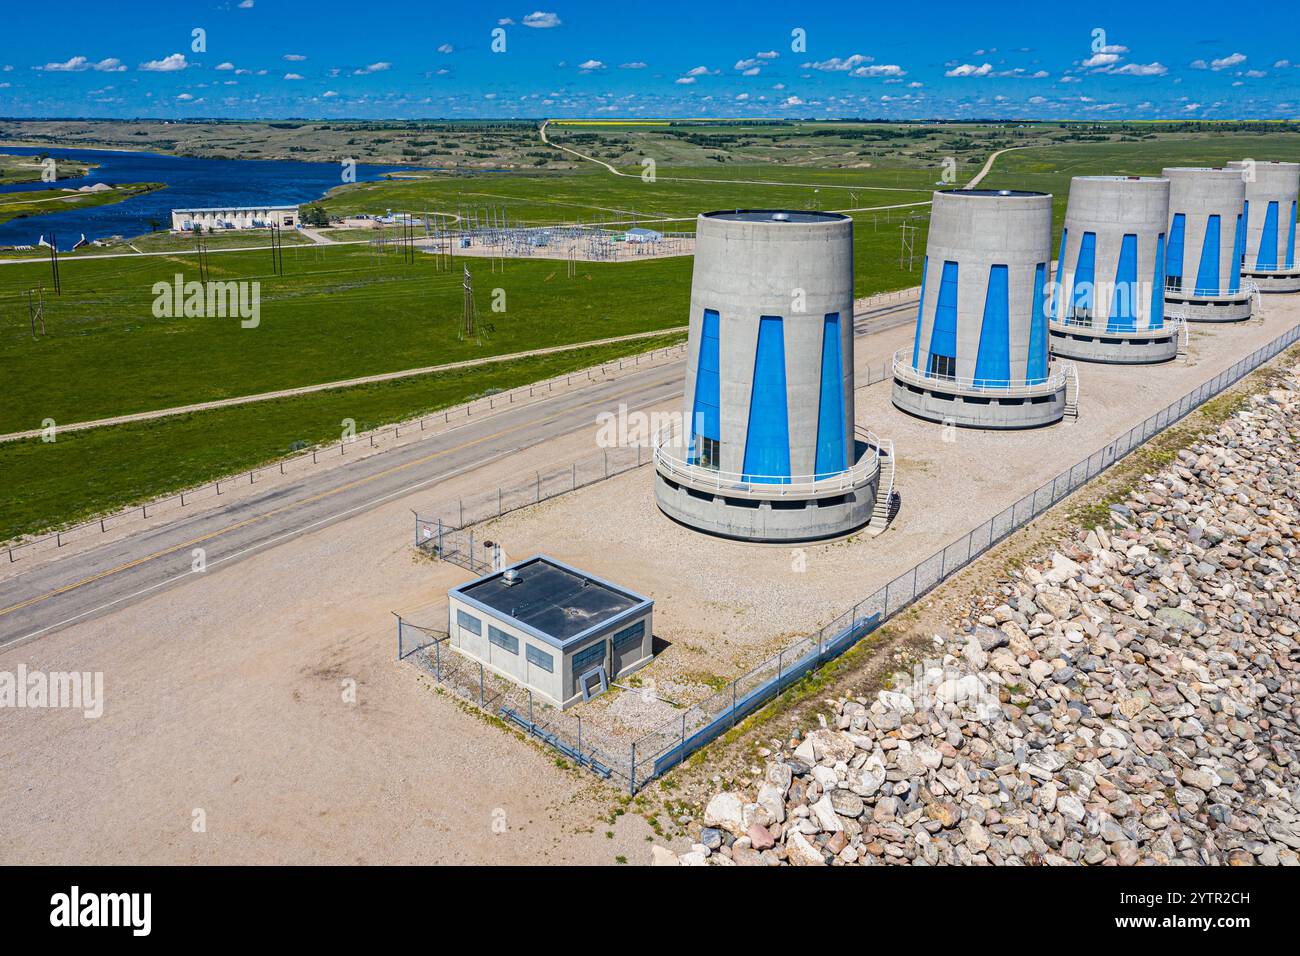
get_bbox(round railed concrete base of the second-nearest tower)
[893,372,1066,429]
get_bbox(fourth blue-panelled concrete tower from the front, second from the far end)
[1162,166,1251,323]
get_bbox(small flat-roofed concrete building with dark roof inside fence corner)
[447,554,654,708]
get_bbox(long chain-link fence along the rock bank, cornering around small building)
[398,319,1300,792]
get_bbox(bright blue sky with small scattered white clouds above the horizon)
[0,0,1300,120]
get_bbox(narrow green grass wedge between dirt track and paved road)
[0,333,684,541]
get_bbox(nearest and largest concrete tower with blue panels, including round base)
[655,209,880,541]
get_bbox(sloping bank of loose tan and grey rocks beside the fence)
[653,367,1300,866]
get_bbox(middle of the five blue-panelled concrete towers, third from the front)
[1048,176,1182,364]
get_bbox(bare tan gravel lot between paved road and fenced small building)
[0,426,670,864]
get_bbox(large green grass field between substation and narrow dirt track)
[0,239,690,433]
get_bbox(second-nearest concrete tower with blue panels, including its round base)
[893,189,1073,428]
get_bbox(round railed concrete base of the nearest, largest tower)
[654,449,880,544]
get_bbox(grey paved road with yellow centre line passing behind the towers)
[0,302,915,646]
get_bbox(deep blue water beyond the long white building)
[0,144,406,250]
